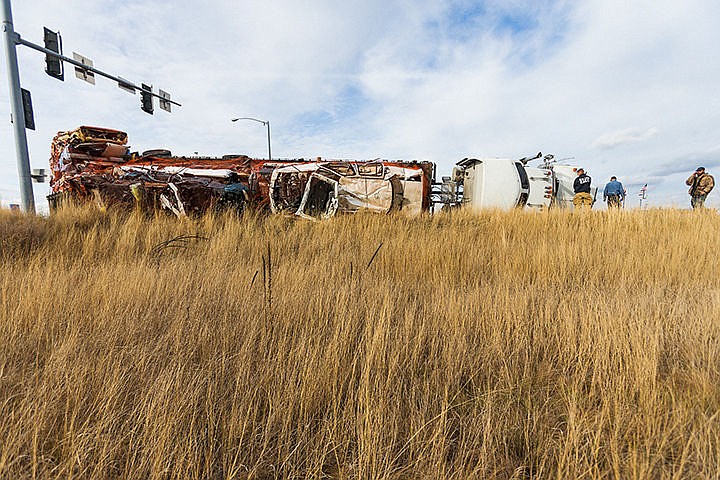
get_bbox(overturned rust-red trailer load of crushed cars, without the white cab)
[48,127,434,219]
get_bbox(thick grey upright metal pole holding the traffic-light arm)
[2,0,35,214]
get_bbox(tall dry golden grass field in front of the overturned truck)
[0,209,720,479]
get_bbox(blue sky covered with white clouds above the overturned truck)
[0,0,720,209]
